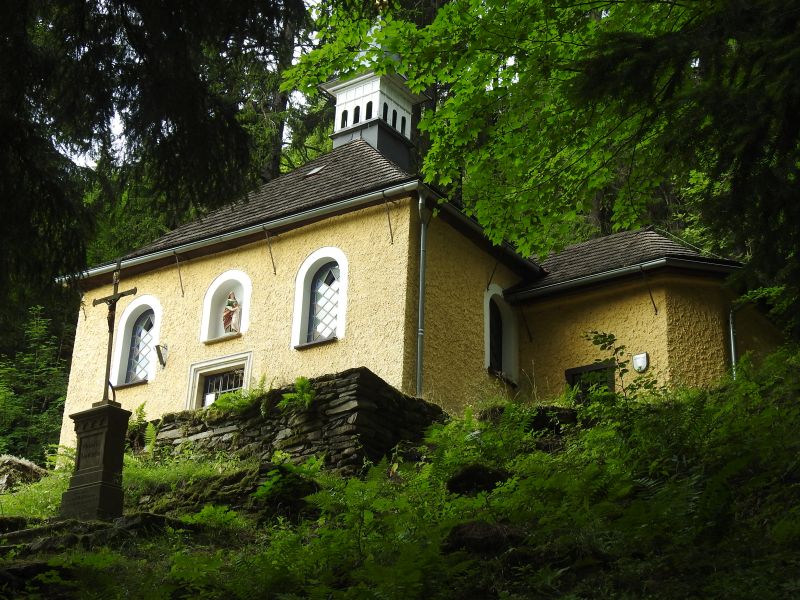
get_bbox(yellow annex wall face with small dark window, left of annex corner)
[520,278,669,400]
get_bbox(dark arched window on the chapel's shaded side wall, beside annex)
[483,283,519,382]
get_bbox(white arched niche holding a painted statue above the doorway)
[200,270,253,342]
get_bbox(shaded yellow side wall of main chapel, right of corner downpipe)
[422,217,519,414]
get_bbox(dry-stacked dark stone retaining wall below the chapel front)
[156,367,444,474]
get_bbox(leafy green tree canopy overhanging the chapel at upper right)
[286,0,800,330]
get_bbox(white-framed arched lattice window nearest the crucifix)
[110,295,162,386]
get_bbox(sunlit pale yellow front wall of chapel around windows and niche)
[61,199,416,445]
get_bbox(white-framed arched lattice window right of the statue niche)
[292,247,348,348]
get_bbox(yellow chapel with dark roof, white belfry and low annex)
[61,72,778,445]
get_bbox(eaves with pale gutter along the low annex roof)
[505,256,741,303]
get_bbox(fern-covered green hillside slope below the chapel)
[0,350,800,600]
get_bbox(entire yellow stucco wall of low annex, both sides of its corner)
[520,272,781,400]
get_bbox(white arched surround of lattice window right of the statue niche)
[291,246,349,348]
